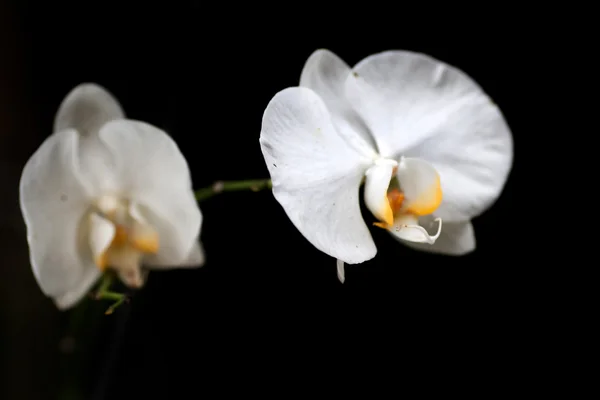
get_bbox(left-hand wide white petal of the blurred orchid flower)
[19,130,99,307]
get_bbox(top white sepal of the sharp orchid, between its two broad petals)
[300,49,377,157]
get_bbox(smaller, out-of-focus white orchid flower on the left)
[20,84,204,309]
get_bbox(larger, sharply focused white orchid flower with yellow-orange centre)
[260,50,513,282]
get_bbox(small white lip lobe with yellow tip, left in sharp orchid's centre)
[364,159,398,225]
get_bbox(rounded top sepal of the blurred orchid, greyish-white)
[54,83,125,134]
